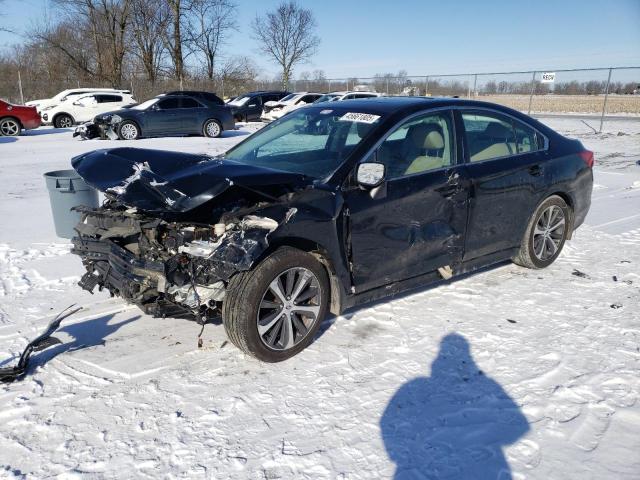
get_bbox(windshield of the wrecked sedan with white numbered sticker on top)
[225,107,381,178]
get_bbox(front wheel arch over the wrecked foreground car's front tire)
[256,237,345,315]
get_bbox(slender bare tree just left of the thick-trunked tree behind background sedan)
[131,0,169,86]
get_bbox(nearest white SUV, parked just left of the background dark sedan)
[41,92,136,128]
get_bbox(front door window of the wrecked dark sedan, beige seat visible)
[377,112,455,179]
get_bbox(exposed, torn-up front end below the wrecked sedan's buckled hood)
[72,201,291,317]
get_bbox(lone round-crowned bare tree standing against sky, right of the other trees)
[251,1,320,90]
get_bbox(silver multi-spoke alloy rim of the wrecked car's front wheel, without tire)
[257,267,322,350]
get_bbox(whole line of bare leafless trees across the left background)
[0,0,320,100]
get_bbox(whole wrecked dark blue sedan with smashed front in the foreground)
[67,97,593,362]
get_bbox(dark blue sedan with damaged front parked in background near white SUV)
[74,95,235,140]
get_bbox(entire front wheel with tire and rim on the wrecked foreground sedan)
[222,247,330,363]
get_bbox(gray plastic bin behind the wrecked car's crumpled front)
[44,170,98,238]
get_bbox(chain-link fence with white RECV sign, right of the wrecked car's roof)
[292,67,640,130]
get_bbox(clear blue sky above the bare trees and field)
[0,0,640,77]
